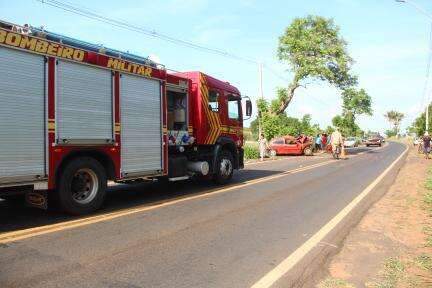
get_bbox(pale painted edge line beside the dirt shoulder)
[251,143,409,288]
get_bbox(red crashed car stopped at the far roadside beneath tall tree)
[269,136,313,156]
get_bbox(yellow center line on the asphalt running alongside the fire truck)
[0,160,336,244]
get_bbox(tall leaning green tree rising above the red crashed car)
[271,15,357,114]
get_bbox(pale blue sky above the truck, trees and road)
[0,0,432,132]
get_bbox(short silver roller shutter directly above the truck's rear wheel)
[57,61,113,143]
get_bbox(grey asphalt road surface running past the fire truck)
[0,143,405,288]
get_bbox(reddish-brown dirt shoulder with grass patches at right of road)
[317,145,432,288]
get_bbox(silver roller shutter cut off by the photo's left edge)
[0,47,45,183]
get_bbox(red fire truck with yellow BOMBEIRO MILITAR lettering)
[0,22,252,214]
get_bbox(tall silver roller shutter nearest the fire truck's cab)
[120,74,162,177]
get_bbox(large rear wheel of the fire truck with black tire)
[56,157,107,215]
